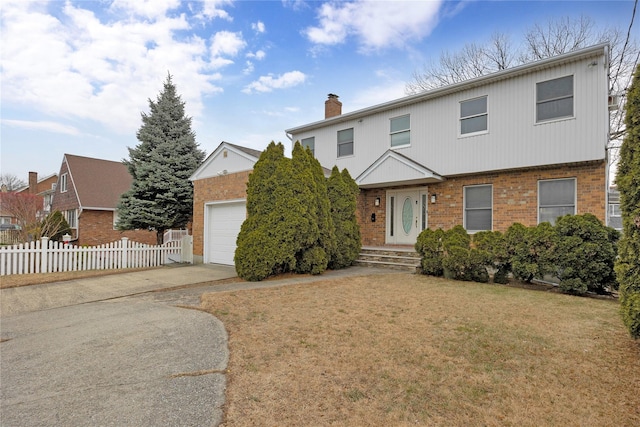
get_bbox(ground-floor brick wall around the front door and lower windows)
[358,161,607,246]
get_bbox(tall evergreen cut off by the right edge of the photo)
[615,65,640,338]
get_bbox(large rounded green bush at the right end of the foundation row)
[553,213,619,295]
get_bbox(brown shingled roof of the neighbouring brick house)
[63,154,133,210]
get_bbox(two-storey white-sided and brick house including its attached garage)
[191,44,609,263]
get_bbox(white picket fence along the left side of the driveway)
[0,237,184,276]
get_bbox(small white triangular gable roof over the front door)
[355,150,444,188]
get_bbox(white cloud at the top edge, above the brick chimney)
[306,0,442,51]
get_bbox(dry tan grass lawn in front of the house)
[202,273,640,426]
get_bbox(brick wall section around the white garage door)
[193,171,251,257]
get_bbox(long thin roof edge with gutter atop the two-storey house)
[285,43,609,135]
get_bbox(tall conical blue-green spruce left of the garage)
[117,74,205,244]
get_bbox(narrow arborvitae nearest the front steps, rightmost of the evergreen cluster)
[327,166,362,270]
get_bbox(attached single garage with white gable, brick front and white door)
[190,142,261,265]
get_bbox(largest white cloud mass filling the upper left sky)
[0,0,225,133]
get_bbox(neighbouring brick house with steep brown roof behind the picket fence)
[52,154,156,246]
